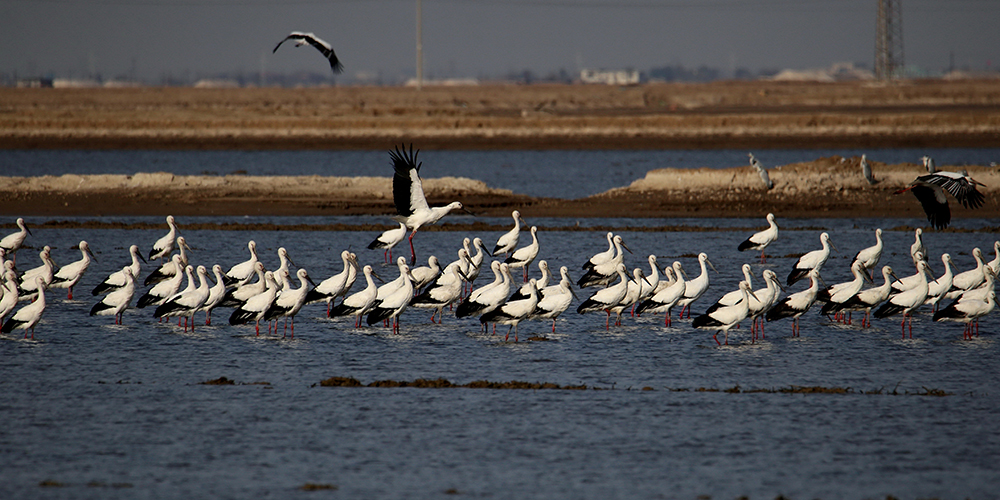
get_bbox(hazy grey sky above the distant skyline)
[0,0,1000,81]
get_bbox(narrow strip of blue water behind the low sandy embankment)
[0,148,1000,199]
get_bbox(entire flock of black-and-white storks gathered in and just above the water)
[0,146,1000,344]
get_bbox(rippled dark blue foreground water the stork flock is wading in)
[0,217,1000,499]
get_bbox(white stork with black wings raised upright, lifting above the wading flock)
[389,144,472,264]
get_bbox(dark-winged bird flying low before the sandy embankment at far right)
[896,169,986,229]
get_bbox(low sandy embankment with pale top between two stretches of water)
[0,157,1000,223]
